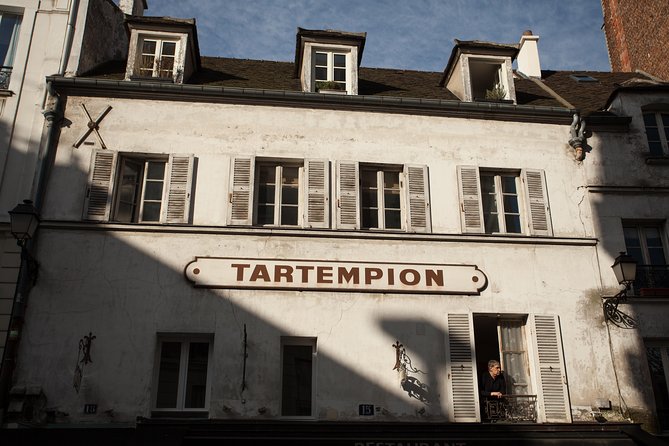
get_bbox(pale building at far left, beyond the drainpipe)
[0,0,136,426]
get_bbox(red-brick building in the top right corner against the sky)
[602,0,669,81]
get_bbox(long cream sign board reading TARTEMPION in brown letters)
[185,257,488,294]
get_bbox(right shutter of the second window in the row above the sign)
[304,160,330,228]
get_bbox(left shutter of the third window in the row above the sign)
[337,161,360,229]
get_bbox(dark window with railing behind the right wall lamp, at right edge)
[623,222,669,294]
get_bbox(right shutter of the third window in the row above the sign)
[404,165,432,232]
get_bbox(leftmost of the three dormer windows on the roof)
[125,16,200,84]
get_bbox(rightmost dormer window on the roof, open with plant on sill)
[439,40,518,103]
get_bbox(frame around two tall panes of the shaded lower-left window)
[151,333,214,415]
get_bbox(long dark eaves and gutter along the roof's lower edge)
[46,76,578,124]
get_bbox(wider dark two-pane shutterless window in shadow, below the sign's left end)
[154,336,211,411]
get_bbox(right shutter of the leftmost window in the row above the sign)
[161,155,194,223]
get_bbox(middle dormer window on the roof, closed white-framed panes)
[295,28,366,94]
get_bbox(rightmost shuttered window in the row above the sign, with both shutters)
[458,166,553,235]
